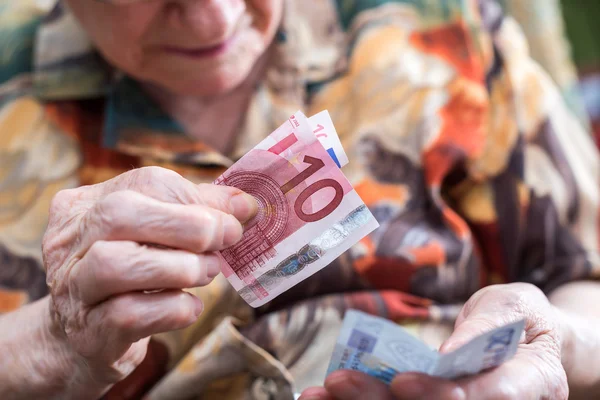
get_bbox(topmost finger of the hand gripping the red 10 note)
[94,167,258,222]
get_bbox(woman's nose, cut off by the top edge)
[165,0,246,39]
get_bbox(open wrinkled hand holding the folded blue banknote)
[300,283,569,400]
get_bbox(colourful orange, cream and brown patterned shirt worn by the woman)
[0,0,600,399]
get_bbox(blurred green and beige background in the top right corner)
[501,0,600,146]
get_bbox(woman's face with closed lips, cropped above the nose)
[67,0,283,96]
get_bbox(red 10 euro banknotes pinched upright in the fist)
[215,112,379,307]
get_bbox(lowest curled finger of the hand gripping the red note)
[86,290,203,360]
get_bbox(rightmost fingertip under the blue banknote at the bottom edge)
[390,373,466,400]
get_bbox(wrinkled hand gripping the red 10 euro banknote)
[43,167,257,388]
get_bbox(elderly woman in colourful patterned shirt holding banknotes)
[0,0,600,400]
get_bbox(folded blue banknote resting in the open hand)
[327,310,525,384]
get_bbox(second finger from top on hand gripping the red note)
[79,191,243,253]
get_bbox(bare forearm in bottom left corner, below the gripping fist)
[0,297,108,400]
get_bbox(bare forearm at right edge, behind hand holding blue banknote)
[548,282,600,399]
